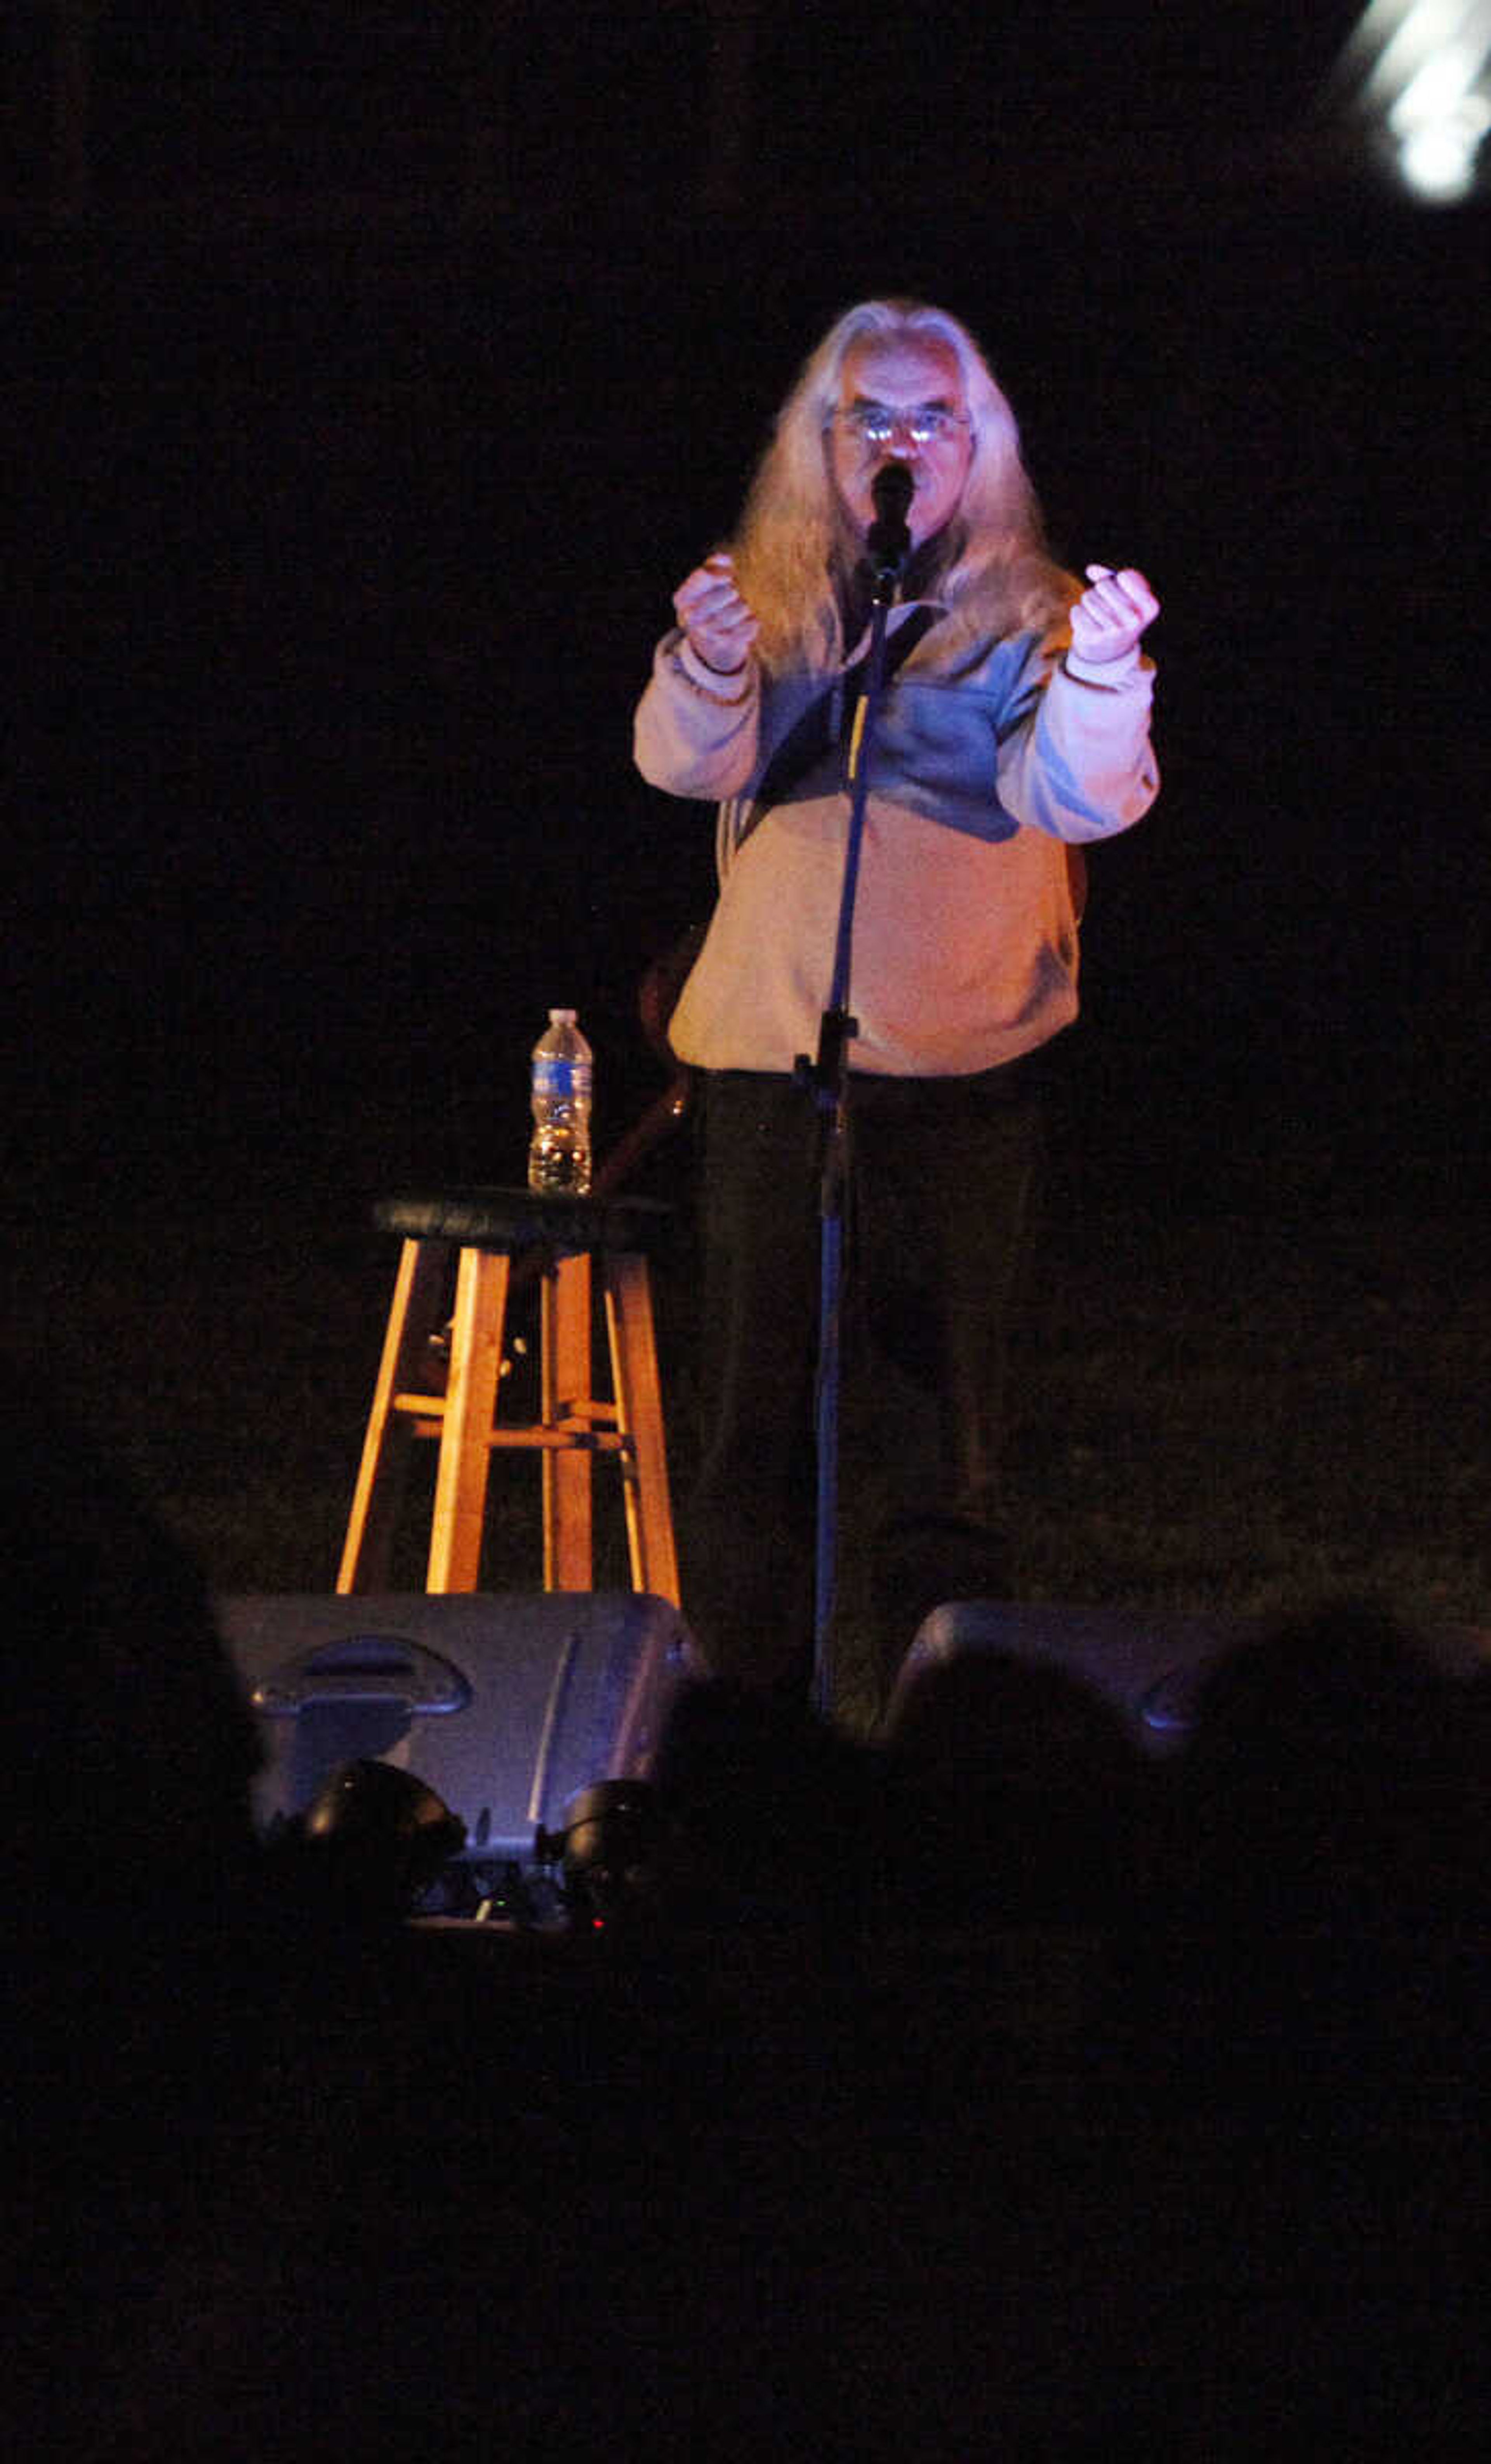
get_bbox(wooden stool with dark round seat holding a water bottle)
[338,1190,678,1606]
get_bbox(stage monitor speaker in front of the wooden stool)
[214,1592,700,1865]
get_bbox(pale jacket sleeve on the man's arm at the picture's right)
[998,636,1161,843]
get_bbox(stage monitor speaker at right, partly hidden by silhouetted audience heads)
[885,1599,1242,1754]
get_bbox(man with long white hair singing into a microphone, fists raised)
[636,300,1158,1725]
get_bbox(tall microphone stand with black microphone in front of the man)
[796,463,912,1720]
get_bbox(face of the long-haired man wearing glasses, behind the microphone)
[828,338,973,547]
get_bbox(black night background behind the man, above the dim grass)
[2,0,1489,1207]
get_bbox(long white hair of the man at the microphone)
[732,298,1077,673]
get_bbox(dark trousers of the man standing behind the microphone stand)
[683,1057,1043,1725]
